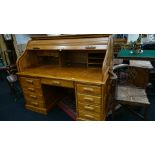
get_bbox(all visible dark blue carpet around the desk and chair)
[0,70,155,121]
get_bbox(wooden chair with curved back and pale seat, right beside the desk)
[111,64,150,120]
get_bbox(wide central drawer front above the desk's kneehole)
[41,79,74,88]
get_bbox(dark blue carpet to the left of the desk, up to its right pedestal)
[0,77,72,121]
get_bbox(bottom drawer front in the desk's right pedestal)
[78,110,102,121]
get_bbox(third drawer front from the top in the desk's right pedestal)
[78,102,101,113]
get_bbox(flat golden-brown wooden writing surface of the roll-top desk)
[18,65,102,84]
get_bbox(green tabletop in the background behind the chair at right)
[117,49,155,59]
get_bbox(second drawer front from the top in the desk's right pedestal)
[77,94,101,106]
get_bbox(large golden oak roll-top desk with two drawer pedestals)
[17,35,112,120]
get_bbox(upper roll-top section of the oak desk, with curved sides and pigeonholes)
[17,34,112,79]
